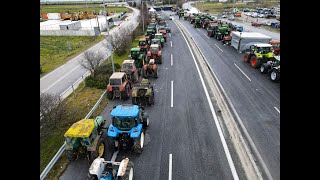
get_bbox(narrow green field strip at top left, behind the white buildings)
[42,4,131,13]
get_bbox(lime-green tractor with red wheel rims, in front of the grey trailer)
[243,43,274,68]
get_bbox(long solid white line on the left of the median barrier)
[177,20,239,180]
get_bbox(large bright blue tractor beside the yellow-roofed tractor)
[108,104,149,154]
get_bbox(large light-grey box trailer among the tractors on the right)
[231,31,272,52]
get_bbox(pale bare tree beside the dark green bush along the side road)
[80,51,103,77]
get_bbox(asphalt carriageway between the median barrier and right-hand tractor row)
[170,9,280,180]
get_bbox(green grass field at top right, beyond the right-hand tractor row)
[192,1,278,14]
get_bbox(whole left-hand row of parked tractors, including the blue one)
[64,10,170,180]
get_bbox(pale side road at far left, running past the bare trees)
[40,8,140,95]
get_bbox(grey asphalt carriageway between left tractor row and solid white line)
[60,13,240,180]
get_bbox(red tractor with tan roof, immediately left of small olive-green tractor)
[107,72,132,100]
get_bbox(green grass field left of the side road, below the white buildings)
[40,35,105,76]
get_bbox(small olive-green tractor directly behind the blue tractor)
[132,78,154,105]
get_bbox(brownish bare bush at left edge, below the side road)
[40,93,65,139]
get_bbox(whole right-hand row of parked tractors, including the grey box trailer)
[176,9,280,82]
